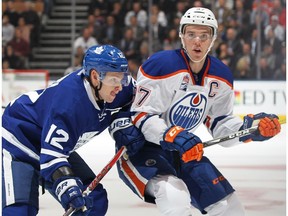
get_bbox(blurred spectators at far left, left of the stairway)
[2,0,42,69]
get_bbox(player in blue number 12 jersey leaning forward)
[2,45,143,216]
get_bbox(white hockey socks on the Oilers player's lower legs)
[146,175,245,216]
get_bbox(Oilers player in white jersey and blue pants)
[112,8,281,216]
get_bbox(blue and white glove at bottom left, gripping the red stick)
[53,176,93,215]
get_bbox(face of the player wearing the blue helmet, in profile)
[99,72,124,103]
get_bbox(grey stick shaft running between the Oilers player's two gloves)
[203,121,286,148]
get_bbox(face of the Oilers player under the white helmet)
[183,25,212,60]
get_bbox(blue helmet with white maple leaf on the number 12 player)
[83,45,128,84]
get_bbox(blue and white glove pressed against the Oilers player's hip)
[109,112,145,156]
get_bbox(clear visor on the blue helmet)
[101,72,128,86]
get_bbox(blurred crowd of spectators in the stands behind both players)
[2,0,286,80]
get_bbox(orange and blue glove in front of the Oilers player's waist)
[160,126,203,163]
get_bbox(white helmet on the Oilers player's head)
[179,7,218,37]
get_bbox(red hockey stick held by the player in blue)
[63,146,127,216]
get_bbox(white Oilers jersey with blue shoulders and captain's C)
[132,49,242,146]
